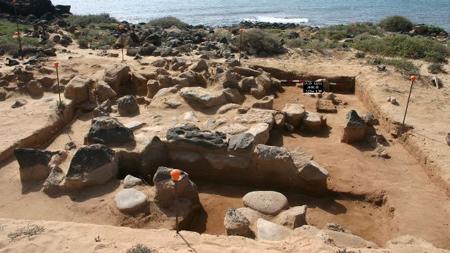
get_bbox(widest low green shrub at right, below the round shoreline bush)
[353,34,450,62]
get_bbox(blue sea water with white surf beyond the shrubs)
[52,0,450,31]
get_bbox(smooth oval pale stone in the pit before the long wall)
[243,191,289,215]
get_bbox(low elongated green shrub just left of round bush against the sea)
[319,23,383,40]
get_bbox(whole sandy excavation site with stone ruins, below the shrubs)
[0,11,450,252]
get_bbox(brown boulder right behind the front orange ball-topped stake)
[153,167,200,208]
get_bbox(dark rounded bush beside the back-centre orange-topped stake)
[234,28,286,56]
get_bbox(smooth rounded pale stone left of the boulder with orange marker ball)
[114,188,147,213]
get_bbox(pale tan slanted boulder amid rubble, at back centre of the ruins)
[180,87,227,108]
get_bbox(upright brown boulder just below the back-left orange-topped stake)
[103,64,131,94]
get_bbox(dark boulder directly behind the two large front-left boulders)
[86,117,134,146]
